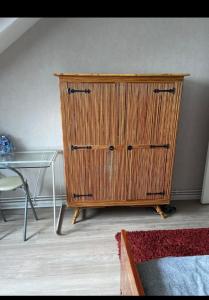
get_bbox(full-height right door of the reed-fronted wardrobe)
[126,82,181,201]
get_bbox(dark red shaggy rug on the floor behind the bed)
[115,228,209,263]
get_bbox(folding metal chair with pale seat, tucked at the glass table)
[0,167,38,241]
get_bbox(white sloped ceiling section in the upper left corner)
[0,18,40,54]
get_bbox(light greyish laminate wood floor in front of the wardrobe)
[0,200,209,295]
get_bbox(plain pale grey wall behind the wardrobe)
[0,18,209,204]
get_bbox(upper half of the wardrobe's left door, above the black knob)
[62,82,125,145]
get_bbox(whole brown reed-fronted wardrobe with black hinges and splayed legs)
[55,73,189,222]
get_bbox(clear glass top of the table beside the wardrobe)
[0,150,57,168]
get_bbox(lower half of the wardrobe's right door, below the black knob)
[126,146,169,201]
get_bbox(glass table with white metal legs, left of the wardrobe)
[0,150,58,233]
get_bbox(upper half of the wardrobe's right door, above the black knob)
[126,82,182,145]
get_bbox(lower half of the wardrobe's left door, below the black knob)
[66,146,126,205]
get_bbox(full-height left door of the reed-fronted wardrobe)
[59,82,125,205]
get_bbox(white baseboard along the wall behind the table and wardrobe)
[0,190,202,209]
